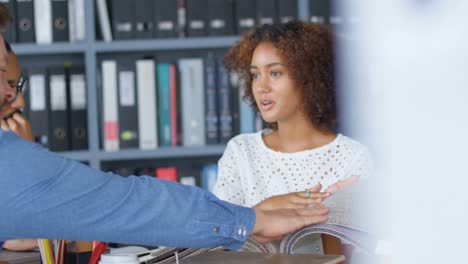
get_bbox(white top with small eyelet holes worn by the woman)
[213,130,371,207]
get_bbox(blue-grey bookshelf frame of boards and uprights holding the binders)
[12,0,309,169]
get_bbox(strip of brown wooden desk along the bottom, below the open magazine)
[180,251,345,264]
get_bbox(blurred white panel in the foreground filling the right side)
[337,0,468,263]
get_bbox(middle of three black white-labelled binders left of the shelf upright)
[48,66,70,151]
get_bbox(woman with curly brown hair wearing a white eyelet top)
[214,21,371,214]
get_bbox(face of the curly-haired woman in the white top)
[250,42,302,123]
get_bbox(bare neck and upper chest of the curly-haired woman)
[264,117,336,153]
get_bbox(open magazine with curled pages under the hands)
[241,181,377,254]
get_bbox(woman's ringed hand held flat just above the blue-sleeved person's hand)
[255,184,330,210]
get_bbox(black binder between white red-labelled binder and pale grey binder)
[117,58,139,149]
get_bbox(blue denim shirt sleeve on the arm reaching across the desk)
[0,130,255,249]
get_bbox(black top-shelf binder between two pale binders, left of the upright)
[52,0,70,42]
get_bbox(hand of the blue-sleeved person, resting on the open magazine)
[250,205,328,243]
